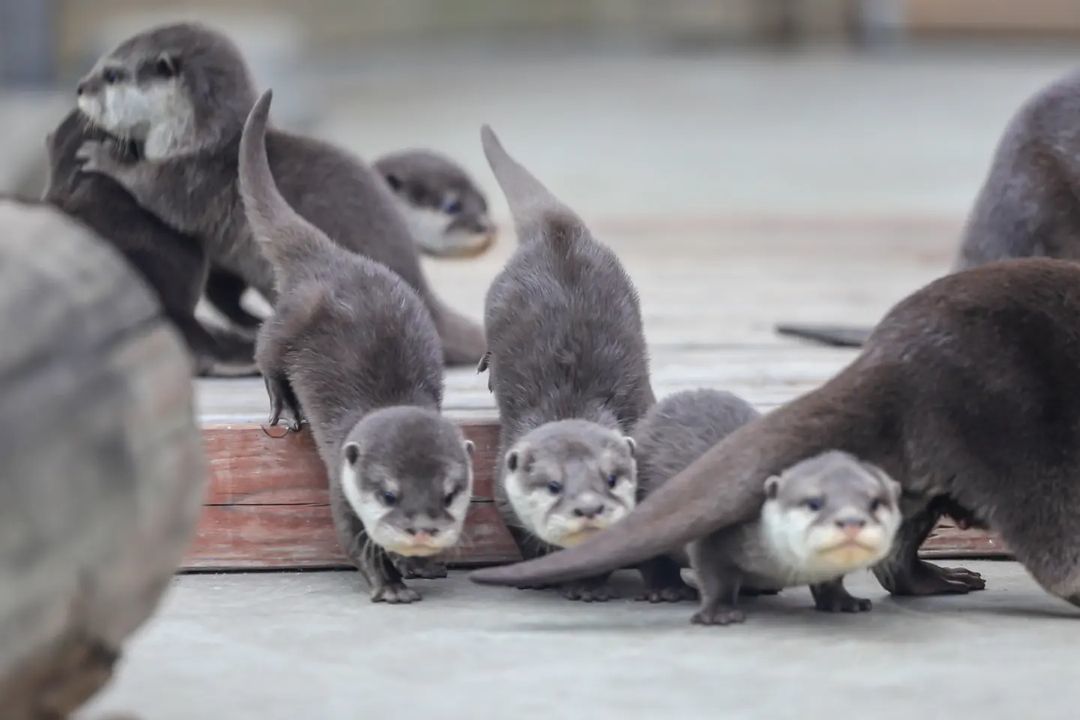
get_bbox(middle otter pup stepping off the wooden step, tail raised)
[480,126,654,601]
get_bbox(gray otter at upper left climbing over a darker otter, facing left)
[78,24,484,363]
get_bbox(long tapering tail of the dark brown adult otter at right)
[470,397,832,586]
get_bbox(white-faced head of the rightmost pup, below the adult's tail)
[761,450,901,581]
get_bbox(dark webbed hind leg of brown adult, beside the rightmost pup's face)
[874,507,986,595]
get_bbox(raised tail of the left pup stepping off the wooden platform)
[240,90,335,278]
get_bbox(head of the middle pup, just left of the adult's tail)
[503,420,637,547]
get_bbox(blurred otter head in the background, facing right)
[375,150,496,258]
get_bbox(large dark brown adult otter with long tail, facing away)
[472,259,1080,621]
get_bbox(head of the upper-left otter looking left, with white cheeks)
[77,23,255,159]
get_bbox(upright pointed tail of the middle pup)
[480,125,589,248]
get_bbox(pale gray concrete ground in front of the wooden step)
[84,562,1080,720]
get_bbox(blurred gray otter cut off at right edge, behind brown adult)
[777,72,1080,348]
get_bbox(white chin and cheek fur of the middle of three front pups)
[505,473,634,547]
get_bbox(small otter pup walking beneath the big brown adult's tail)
[634,390,900,625]
